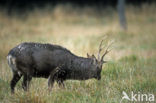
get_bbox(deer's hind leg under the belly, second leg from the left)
[22,75,32,91]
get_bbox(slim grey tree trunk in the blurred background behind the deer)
[117,0,127,30]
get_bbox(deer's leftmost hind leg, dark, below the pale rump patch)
[10,73,22,93]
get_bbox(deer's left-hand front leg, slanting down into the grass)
[48,67,60,91]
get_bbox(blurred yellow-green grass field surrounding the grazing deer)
[0,4,156,103]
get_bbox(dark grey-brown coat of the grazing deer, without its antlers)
[7,43,101,92]
